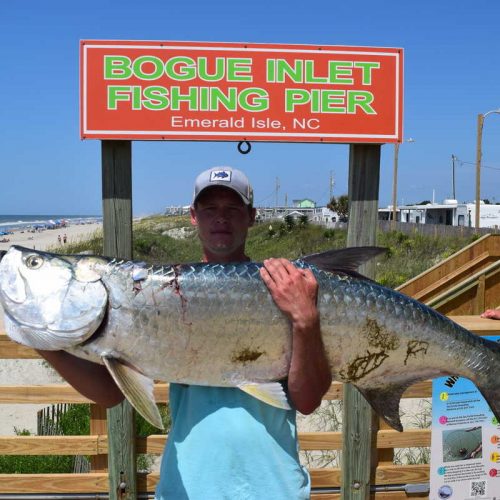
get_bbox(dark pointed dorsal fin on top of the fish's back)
[301,247,387,281]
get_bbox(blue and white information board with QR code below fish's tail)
[429,336,500,500]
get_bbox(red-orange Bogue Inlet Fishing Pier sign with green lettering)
[80,40,403,143]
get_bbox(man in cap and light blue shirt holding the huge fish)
[156,167,331,500]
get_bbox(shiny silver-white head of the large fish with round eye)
[0,246,108,350]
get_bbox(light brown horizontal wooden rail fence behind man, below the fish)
[0,316,500,500]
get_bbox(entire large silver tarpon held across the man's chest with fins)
[0,246,500,430]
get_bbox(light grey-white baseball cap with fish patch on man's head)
[193,167,253,205]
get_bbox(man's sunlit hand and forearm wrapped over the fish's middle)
[260,259,332,415]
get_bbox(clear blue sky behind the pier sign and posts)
[0,0,500,215]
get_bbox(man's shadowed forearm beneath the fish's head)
[37,350,124,408]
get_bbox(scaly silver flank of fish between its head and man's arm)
[78,263,291,386]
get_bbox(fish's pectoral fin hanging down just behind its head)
[102,356,163,429]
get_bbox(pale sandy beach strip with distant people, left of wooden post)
[0,222,102,254]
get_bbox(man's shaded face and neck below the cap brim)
[191,186,255,262]
